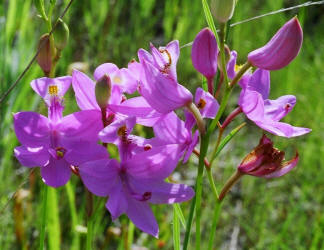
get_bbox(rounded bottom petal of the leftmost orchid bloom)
[41,157,71,187]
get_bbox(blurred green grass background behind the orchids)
[0,0,324,250]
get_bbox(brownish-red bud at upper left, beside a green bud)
[36,34,52,76]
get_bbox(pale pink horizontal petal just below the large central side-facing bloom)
[109,96,164,127]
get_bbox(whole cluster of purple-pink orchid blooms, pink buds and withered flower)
[14,5,310,244]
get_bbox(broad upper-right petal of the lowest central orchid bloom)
[123,144,181,180]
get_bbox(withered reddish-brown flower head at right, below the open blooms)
[238,135,298,178]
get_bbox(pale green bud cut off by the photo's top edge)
[211,0,236,23]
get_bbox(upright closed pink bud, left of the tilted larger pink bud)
[191,28,218,78]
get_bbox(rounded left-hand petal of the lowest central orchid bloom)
[79,159,121,196]
